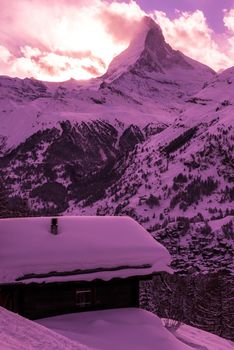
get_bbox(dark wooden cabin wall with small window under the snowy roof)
[0,278,139,319]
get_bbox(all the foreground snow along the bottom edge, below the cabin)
[0,307,234,350]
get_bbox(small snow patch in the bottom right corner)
[175,324,234,350]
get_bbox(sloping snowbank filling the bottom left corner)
[0,307,91,350]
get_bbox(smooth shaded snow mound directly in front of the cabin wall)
[37,308,192,350]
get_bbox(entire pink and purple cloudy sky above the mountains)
[0,0,234,81]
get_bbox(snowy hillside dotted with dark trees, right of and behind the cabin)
[76,113,234,272]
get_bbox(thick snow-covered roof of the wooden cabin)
[0,216,170,283]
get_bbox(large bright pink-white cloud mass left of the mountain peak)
[0,0,144,81]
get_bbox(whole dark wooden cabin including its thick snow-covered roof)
[0,216,170,319]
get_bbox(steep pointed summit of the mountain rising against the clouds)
[103,16,215,81]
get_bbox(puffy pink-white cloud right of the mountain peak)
[153,10,234,71]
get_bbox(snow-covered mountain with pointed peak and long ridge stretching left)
[0,17,215,151]
